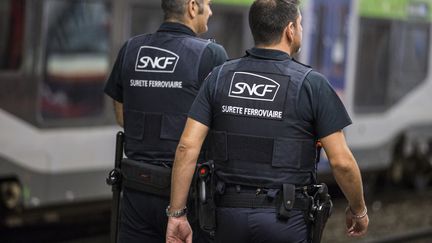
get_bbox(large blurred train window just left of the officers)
[39,0,110,123]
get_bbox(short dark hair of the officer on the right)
[249,0,300,45]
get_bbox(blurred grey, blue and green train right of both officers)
[302,0,432,191]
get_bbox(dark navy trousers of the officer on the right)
[215,208,309,243]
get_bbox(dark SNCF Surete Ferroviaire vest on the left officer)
[121,32,210,161]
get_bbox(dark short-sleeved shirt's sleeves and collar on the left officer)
[105,22,228,103]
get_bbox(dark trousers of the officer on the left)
[119,188,212,243]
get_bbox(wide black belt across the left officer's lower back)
[121,159,171,197]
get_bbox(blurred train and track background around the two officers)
[0,0,432,243]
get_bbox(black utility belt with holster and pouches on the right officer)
[196,161,333,243]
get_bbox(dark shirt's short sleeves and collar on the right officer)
[189,48,352,138]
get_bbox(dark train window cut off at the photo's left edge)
[0,0,25,70]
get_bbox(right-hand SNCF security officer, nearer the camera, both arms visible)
[166,0,369,242]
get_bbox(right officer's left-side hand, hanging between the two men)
[166,216,192,243]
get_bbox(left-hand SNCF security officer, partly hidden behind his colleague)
[105,0,227,243]
